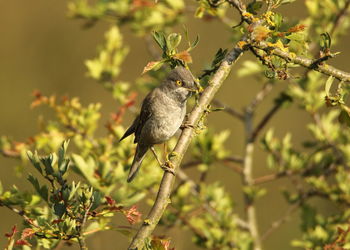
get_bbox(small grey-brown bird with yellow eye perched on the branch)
[119,66,197,182]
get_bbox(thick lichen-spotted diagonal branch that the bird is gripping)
[128,40,243,249]
